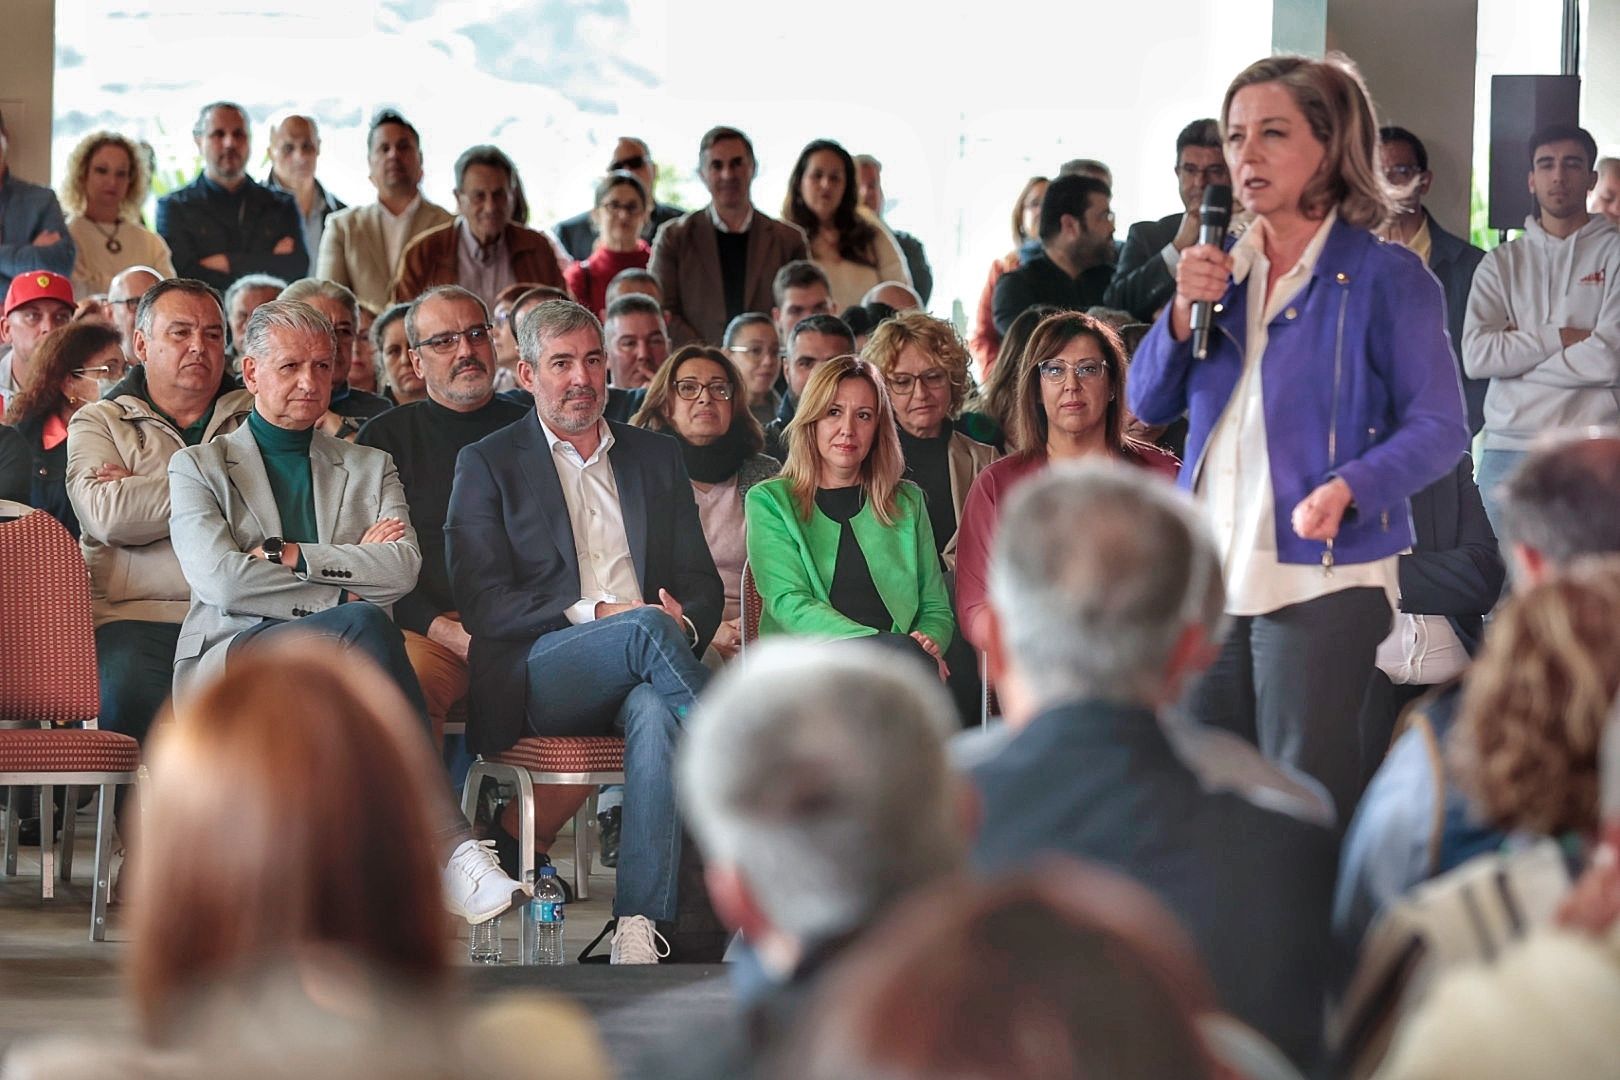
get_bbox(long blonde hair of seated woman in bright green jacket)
[782,355,906,525]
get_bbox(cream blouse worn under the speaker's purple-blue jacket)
[1196,210,1396,615]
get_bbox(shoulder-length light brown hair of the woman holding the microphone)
[1220,52,1396,228]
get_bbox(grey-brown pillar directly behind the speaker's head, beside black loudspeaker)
[1328,0,1483,236]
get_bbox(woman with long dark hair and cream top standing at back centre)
[782,139,912,311]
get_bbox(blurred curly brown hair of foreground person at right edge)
[1452,555,1620,836]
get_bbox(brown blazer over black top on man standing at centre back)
[646,207,810,345]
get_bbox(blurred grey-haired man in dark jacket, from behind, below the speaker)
[970,465,1337,1067]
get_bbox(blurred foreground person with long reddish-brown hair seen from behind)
[6,640,608,1080]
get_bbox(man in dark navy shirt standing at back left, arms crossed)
[157,102,309,293]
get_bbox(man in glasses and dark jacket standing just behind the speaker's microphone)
[1103,120,1231,322]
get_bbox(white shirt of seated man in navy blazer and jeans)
[539,419,642,623]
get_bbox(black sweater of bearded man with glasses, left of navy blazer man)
[355,397,531,635]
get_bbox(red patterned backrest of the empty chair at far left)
[0,510,100,724]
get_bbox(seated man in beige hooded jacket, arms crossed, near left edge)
[68,279,253,751]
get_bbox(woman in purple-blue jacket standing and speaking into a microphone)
[1128,57,1468,824]
